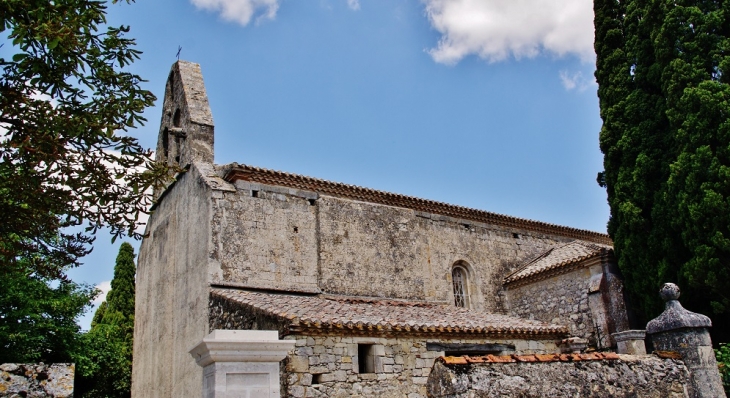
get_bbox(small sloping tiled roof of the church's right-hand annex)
[504,240,613,285]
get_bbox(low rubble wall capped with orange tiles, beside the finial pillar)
[427,355,690,398]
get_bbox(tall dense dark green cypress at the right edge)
[594,0,730,340]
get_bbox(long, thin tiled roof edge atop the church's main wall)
[224,163,612,244]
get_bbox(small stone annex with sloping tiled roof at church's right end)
[505,241,629,349]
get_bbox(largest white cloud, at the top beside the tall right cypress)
[423,0,595,64]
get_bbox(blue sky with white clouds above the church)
[70,0,609,328]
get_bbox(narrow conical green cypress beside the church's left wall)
[77,242,135,397]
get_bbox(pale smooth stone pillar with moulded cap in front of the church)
[190,330,295,398]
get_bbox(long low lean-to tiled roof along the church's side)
[211,288,568,338]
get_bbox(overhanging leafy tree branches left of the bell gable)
[0,0,166,277]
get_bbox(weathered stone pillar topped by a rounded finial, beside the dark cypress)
[646,283,725,398]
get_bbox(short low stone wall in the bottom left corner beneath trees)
[0,363,75,398]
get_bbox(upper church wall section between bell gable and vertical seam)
[212,181,318,292]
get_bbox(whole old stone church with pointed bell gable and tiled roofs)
[132,61,629,398]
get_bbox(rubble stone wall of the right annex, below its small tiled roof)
[507,268,596,346]
